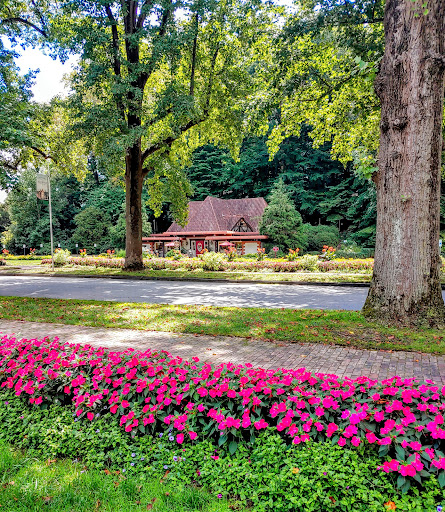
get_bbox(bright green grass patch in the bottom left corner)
[0,445,236,512]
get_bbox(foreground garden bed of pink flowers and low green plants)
[0,337,445,511]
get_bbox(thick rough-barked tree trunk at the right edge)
[363,0,445,326]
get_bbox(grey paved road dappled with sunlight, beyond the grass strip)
[0,276,368,310]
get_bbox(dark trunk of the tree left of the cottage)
[124,140,144,270]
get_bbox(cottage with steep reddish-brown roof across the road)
[142,196,267,256]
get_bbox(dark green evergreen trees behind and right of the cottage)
[187,128,376,250]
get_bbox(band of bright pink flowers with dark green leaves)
[0,336,445,485]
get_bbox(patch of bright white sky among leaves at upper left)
[0,48,76,203]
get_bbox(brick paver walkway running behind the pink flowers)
[0,320,445,384]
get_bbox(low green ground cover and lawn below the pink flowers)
[0,391,445,512]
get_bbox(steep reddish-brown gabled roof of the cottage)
[166,196,267,233]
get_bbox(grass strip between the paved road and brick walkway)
[0,297,445,354]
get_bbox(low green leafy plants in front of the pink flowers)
[0,370,445,512]
